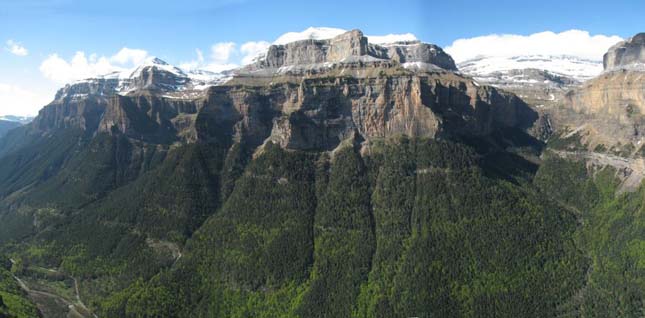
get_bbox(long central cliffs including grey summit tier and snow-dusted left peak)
[21,30,537,154]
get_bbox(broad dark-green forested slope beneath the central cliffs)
[93,138,588,317]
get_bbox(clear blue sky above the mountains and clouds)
[0,0,645,115]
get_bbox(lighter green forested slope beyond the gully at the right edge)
[536,156,645,317]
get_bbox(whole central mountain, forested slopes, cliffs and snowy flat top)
[0,29,645,317]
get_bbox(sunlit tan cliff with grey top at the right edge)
[550,33,645,150]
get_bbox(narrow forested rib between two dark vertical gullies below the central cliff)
[296,147,375,317]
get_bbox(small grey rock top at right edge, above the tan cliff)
[603,33,645,70]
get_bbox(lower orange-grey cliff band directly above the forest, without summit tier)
[89,69,537,150]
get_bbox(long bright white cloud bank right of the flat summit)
[445,30,623,63]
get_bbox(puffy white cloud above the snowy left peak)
[40,48,150,84]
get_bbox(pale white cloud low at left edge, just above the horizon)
[0,83,53,116]
